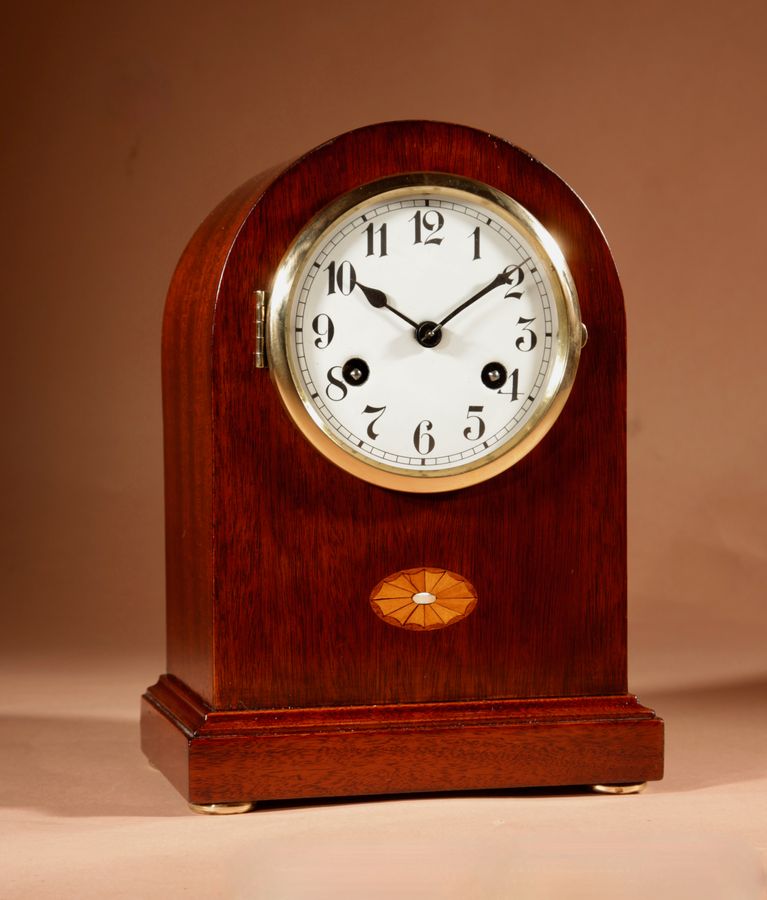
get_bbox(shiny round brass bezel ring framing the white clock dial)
[266,172,582,493]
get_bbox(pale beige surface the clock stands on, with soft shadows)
[0,659,767,900]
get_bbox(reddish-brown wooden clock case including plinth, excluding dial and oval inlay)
[142,122,663,804]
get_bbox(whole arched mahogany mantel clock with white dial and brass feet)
[142,122,663,812]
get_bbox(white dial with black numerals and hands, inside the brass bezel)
[272,172,584,486]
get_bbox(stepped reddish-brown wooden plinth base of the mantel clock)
[141,675,663,804]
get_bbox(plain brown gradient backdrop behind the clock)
[0,0,767,692]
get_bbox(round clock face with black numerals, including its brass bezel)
[268,173,581,491]
